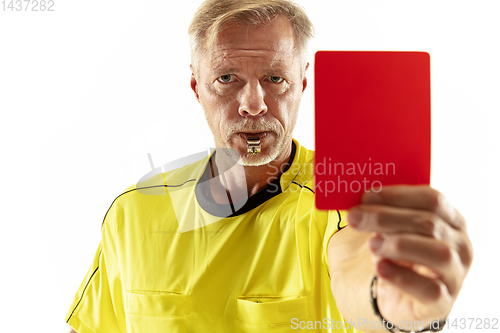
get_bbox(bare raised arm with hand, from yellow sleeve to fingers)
[328,186,473,332]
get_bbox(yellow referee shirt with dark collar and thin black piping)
[66,141,355,333]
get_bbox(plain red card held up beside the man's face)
[315,51,431,209]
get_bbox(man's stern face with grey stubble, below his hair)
[191,16,307,165]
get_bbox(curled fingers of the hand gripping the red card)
[347,185,473,297]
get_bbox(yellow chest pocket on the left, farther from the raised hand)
[126,291,188,333]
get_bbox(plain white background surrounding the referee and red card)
[0,0,500,332]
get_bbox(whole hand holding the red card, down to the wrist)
[347,185,473,324]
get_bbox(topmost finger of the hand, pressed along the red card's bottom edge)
[362,185,466,229]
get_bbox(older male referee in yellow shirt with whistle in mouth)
[67,0,472,333]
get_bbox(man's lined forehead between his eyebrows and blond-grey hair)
[202,16,298,70]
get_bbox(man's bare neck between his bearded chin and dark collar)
[210,142,292,203]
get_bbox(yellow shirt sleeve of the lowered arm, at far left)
[66,204,126,333]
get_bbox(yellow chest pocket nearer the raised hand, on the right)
[236,296,309,332]
